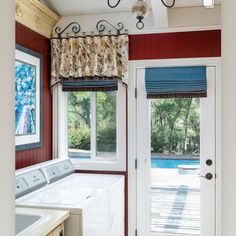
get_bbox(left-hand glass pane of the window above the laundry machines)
[67,92,91,159]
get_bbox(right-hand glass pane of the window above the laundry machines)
[96,91,116,158]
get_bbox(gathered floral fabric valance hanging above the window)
[51,34,129,86]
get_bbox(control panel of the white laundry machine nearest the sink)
[15,169,47,198]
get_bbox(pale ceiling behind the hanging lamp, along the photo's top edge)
[42,0,221,16]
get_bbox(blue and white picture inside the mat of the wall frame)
[15,60,36,136]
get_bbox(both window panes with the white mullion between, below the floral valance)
[67,91,116,161]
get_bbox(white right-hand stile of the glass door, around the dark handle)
[200,66,216,236]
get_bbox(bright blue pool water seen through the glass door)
[151,158,200,169]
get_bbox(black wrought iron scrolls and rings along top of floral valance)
[52,20,128,38]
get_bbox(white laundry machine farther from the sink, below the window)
[43,160,125,236]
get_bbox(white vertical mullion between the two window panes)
[90,92,97,160]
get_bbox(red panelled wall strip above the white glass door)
[129,30,221,60]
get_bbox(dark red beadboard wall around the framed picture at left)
[16,22,52,169]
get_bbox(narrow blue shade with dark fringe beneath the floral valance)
[61,79,118,92]
